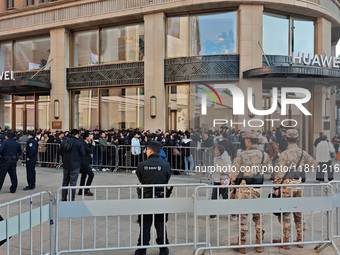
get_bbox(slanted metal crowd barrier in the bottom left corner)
[0,191,53,255]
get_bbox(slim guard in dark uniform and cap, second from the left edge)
[24,132,38,190]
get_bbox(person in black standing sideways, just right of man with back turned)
[78,132,95,196]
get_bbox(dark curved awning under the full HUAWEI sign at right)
[243,66,340,86]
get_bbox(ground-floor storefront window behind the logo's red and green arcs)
[167,84,235,131]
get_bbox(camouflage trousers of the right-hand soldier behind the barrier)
[278,179,306,238]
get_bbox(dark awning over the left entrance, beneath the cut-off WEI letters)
[0,79,51,93]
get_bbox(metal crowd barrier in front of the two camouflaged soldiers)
[195,184,339,254]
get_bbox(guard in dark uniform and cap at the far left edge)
[0,131,21,193]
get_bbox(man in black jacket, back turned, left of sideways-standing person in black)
[60,129,86,201]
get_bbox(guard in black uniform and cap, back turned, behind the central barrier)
[135,141,171,255]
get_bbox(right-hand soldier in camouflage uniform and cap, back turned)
[273,129,317,250]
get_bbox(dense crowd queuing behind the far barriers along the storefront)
[0,126,340,176]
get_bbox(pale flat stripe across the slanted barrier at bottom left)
[0,205,50,240]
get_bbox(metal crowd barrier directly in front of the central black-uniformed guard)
[55,184,204,254]
